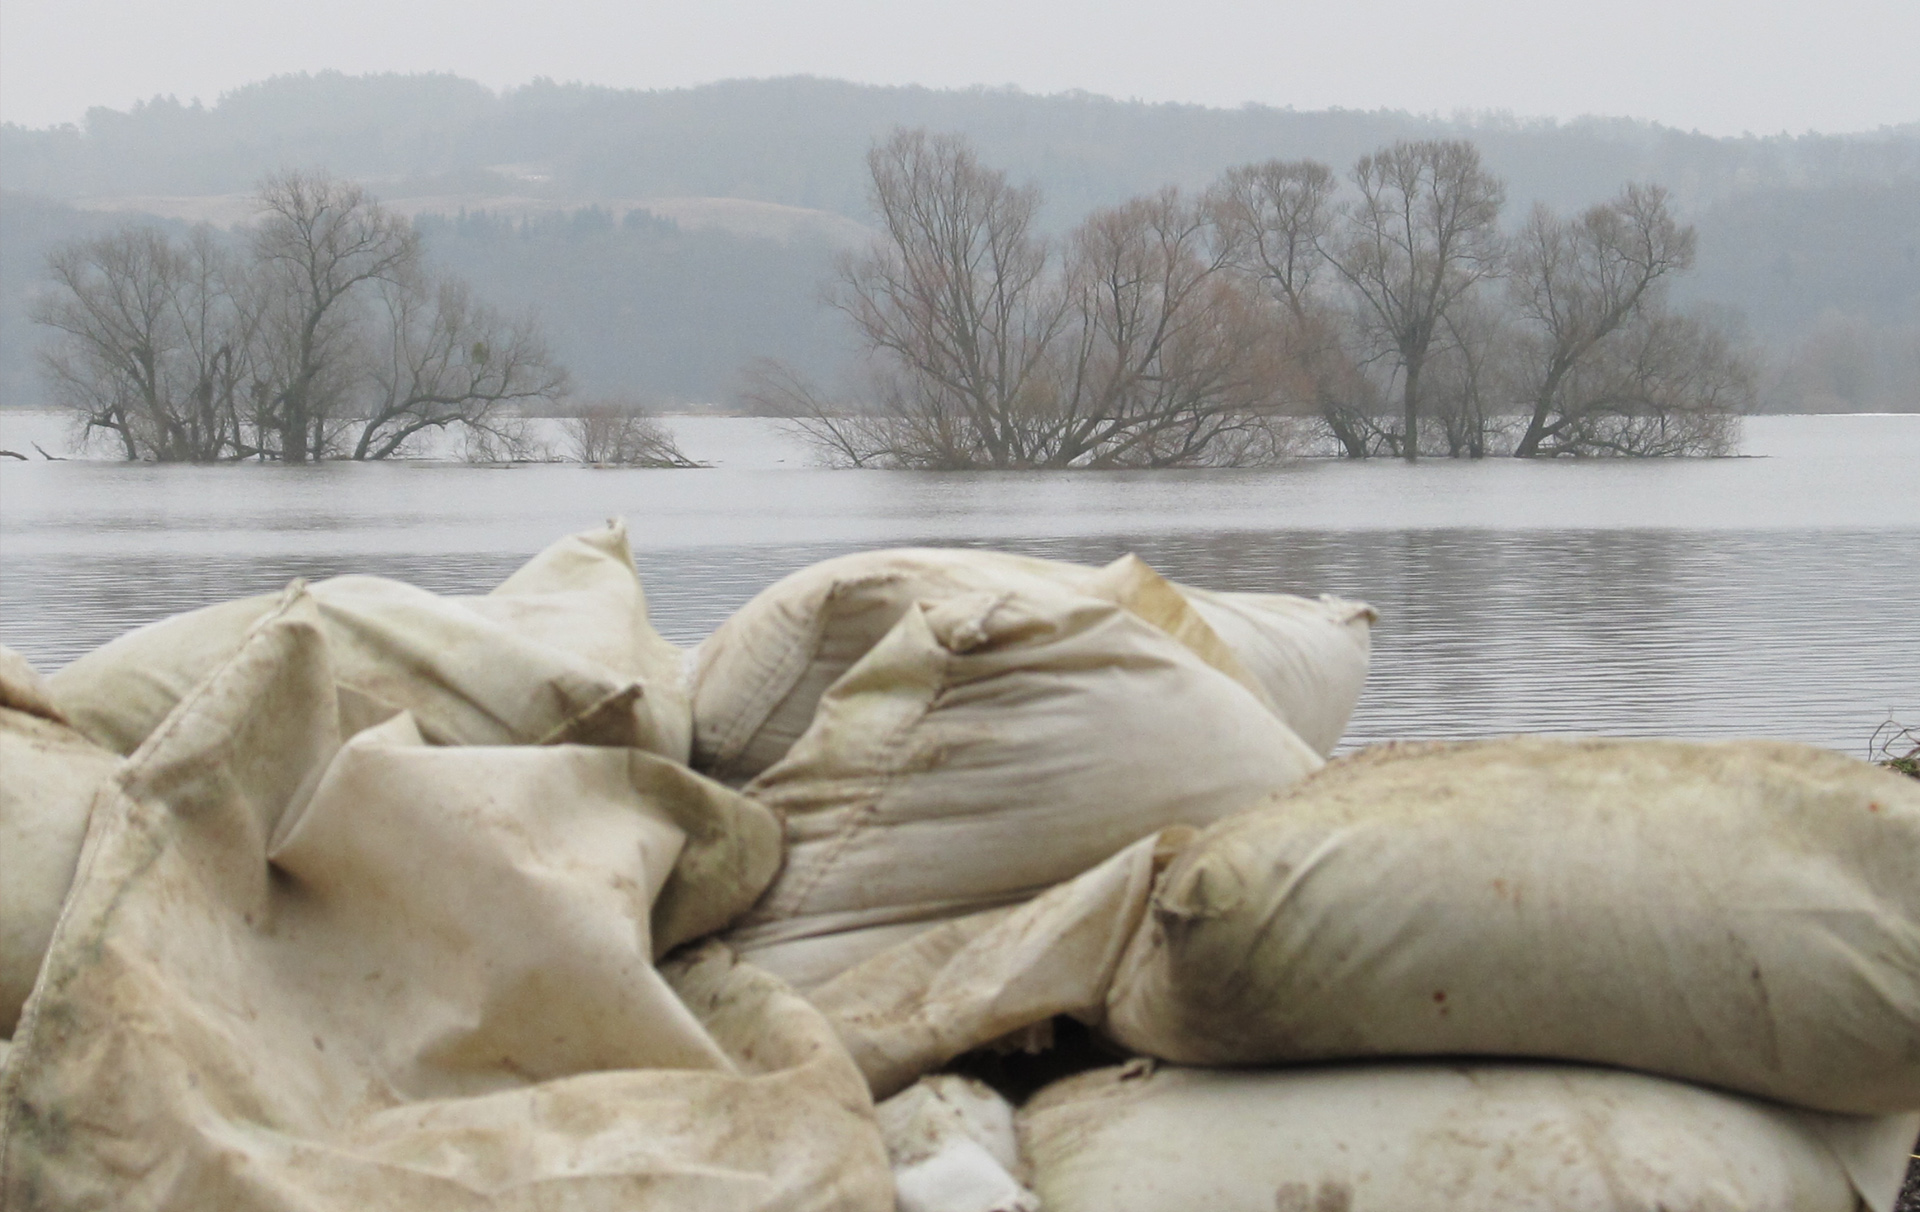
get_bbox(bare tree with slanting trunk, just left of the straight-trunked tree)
[1210,159,1379,459]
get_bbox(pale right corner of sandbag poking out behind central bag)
[1181,586,1379,757]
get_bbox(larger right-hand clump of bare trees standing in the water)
[753,131,1757,469]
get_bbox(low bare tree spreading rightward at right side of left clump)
[353,273,566,459]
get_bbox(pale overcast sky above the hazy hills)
[0,0,1920,134]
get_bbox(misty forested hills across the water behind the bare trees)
[0,73,1920,407]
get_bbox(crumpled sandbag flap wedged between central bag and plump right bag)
[806,826,1194,1097]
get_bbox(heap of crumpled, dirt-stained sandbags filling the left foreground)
[0,536,893,1212]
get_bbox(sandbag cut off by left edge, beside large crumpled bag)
[0,702,119,1035]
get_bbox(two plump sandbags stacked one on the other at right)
[1006,738,1920,1212]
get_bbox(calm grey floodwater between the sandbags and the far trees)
[0,413,1920,755]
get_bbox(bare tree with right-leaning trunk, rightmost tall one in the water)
[1509,184,1718,459]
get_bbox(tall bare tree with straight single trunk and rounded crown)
[1327,140,1505,459]
